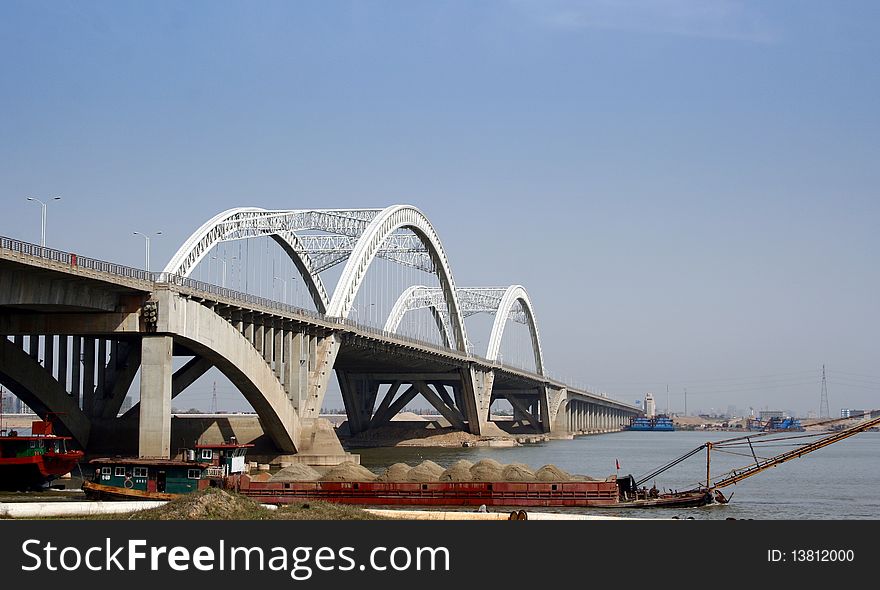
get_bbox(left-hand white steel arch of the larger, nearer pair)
[162,207,330,313]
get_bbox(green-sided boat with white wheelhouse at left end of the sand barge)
[82,440,253,500]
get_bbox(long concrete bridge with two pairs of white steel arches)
[0,205,640,464]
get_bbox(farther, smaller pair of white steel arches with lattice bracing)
[384,285,544,375]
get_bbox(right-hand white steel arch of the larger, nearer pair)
[327,205,467,352]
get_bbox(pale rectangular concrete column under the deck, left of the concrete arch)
[138,336,174,459]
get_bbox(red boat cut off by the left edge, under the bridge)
[0,420,83,490]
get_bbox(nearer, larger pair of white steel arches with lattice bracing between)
[164,205,467,352]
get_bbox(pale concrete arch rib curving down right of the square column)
[170,298,301,453]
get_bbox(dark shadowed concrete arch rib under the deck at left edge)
[0,337,91,449]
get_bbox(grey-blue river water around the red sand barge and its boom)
[352,431,880,520]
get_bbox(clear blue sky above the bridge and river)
[0,0,880,413]
